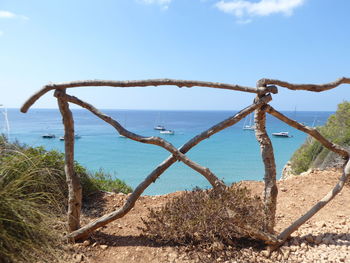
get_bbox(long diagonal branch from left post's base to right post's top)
[67,95,272,240]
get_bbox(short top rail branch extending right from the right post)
[258,77,350,92]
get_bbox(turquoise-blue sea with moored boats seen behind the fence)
[1,109,333,195]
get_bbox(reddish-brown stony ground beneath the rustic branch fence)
[67,170,350,263]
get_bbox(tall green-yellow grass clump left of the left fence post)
[0,138,65,262]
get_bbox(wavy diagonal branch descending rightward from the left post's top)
[55,92,225,187]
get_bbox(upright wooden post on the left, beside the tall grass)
[55,90,82,232]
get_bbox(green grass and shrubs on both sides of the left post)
[0,136,131,262]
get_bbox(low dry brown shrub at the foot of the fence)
[142,185,264,257]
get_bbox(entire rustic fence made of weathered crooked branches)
[21,77,350,247]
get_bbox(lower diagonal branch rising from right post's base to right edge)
[278,160,350,243]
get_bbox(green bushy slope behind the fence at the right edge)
[291,101,350,174]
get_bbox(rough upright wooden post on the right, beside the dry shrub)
[254,96,278,233]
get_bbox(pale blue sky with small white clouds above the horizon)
[0,0,350,111]
